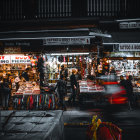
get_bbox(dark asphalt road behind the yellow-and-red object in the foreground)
[64,103,140,140]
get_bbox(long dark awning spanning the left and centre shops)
[0,28,89,40]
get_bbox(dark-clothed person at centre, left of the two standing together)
[56,75,67,110]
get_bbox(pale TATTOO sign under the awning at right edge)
[119,43,140,51]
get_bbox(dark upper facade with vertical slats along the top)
[0,0,140,21]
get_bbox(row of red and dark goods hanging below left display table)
[13,93,58,110]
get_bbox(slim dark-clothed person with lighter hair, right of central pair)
[68,70,77,103]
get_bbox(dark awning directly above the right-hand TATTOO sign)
[103,31,140,45]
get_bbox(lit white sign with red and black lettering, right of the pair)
[11,55,31,63]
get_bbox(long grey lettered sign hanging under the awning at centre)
[43,37,90,45]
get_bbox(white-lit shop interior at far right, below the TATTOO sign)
[108,50,140,87]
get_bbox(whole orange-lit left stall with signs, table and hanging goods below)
[0,54,57,110]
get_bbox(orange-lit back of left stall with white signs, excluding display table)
[0,54,38,89]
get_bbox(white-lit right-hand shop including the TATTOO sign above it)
[103,43,140,85]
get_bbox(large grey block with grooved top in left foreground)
[0,110,64,140]
